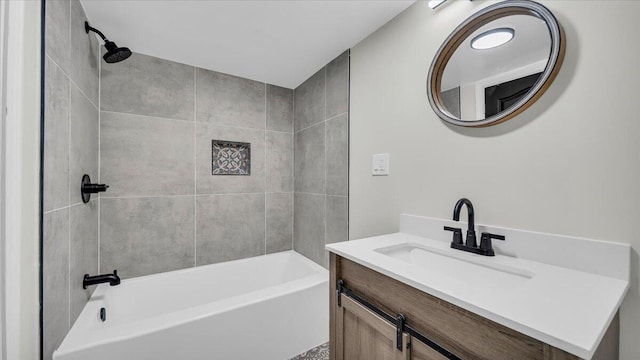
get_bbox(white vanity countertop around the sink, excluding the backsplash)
[326,231,629,359]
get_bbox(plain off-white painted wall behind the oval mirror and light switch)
[350,0,640,360]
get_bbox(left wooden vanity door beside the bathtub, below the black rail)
[335,296,410,360]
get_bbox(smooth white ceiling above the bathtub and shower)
[82,0,415,88]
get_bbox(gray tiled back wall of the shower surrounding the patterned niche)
[100,54,294,278]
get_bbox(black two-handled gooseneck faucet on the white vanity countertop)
[444,198,505,256]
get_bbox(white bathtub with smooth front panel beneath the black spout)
[53,251,329,360]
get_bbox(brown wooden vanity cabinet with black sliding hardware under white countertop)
[330,253,619,360]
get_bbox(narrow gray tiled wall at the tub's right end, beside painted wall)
[293,50,349,266]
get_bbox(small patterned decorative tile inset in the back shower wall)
[211,140,251,175]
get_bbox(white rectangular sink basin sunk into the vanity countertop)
[374,243,535,294]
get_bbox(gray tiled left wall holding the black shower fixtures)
[43,0,99,360]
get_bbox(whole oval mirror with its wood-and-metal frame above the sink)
[427,0,565,127]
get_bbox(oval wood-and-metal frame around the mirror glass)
[427,0,566,127]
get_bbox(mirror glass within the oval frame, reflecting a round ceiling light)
[441,15,551,121]
